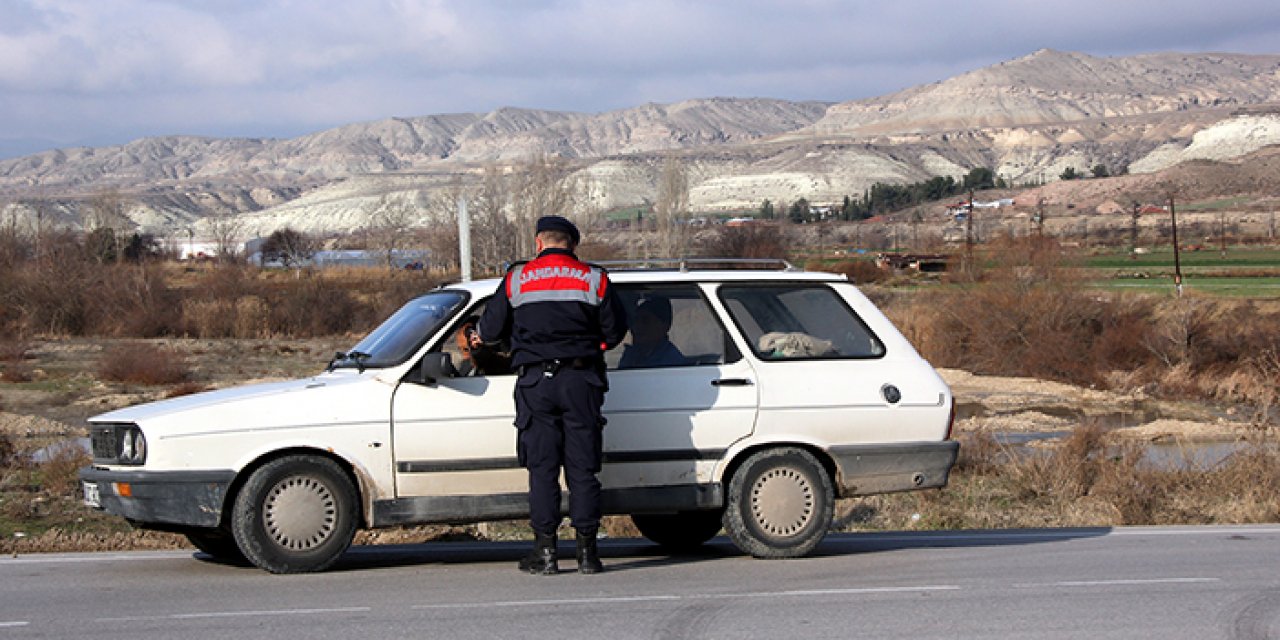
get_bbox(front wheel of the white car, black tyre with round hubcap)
[232,456,357,573]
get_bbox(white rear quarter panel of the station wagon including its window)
[718,283,947,445]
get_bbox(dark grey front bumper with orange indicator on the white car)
[79,467,236,527]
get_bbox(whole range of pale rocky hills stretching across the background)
[0,50,1280,234]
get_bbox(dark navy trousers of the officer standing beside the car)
[516,366,605,536]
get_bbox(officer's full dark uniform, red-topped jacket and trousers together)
[477,248,627,538]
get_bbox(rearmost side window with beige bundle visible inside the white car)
[719,284,884,360]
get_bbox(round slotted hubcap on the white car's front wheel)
[262,476,338,552]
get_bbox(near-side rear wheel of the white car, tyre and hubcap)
[724,447,835,558]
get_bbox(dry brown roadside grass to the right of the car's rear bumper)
[837,425,1280,529]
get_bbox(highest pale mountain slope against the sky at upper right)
[814,49,1280,137]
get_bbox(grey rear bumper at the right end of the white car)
[829,440,960,498]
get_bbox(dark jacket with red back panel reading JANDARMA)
[476,248,627,366]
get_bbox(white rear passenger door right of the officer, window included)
[600,283,758,511]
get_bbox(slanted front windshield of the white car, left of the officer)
[333,291,467,370]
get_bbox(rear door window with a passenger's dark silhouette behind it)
[604,284,742,369]
